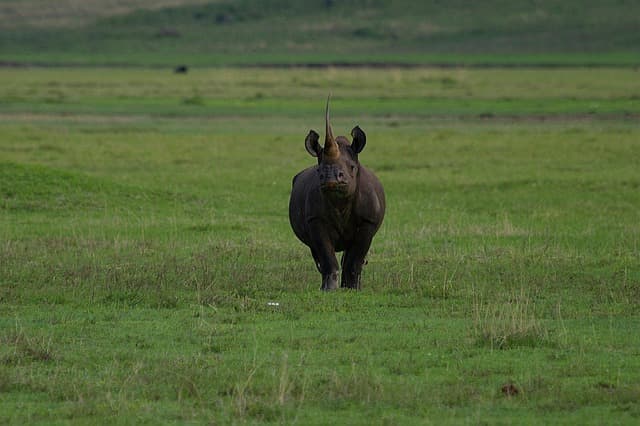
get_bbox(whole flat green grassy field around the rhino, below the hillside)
[0,69,640,425]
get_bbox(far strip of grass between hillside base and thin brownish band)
[0,68,640,118]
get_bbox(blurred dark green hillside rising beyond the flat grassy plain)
[0,0,640,66]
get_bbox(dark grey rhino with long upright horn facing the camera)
[289,99,385,290]
